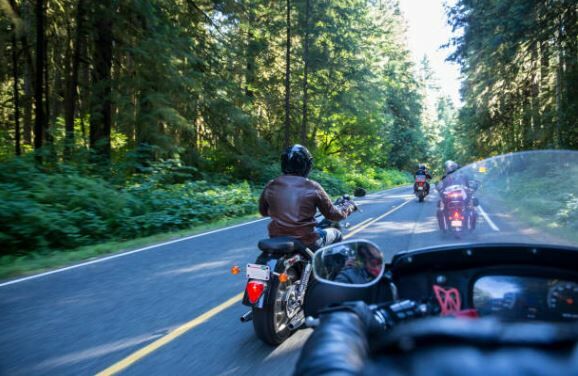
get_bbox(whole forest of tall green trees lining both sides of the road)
[0,0,578,256]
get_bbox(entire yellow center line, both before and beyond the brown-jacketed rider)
[96,198,413,376]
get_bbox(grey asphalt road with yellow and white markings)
[0,188,507,376]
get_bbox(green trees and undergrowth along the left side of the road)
[0,0,426,253]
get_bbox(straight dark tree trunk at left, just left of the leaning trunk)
[34,0,46,162]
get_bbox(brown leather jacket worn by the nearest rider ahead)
[259,175,349,245]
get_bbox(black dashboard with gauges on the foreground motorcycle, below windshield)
[386,243,578,321]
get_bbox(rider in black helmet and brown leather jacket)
[259,144,355,249]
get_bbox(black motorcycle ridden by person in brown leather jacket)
[233,195,358,346]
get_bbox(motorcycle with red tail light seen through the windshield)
[437,185,478,236]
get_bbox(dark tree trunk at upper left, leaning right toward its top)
[64,0,85,158]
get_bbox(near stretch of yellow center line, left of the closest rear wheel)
[96,292,244,376]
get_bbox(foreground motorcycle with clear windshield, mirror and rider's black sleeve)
[295,151,578,375]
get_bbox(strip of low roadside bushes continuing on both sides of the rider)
[0,158,409,255]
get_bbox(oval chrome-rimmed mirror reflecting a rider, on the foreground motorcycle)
[313,240,385,287]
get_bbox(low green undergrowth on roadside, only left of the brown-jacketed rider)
[0,159,256,253]
